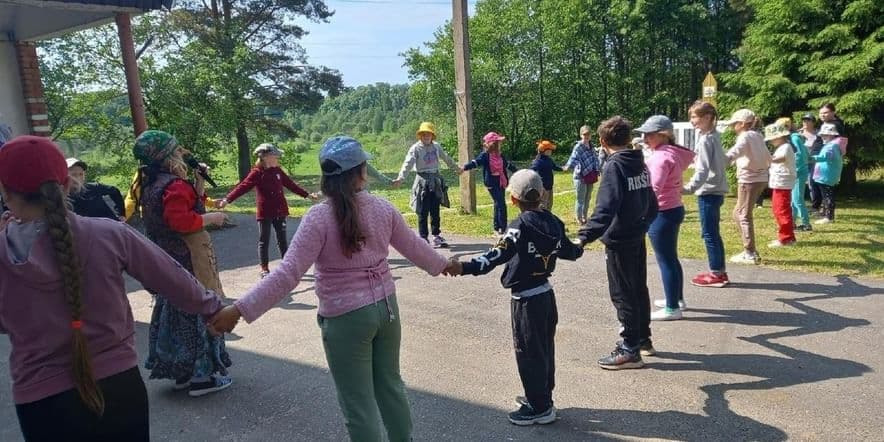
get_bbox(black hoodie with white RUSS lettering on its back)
[578,149,657,247]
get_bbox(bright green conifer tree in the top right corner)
[721,0,884,188]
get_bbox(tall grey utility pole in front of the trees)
[451,0,476,214]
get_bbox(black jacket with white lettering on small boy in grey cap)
[463,210,583,293]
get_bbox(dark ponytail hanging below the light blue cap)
[320,160,365,258]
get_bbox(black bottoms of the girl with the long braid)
[15,367,150,442]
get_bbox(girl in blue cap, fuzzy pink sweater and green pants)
[213,136,451,441]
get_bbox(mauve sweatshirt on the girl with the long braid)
[0,215,222,404]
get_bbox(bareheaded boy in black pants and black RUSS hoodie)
[578,116,657,370]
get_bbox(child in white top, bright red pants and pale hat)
[764,123,797,247]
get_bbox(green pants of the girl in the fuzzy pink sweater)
[318,295,412,442]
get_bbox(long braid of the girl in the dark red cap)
[40,182,104,416]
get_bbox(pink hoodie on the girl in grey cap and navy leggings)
[647,144,695,210]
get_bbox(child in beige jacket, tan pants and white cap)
[725,109,770,264]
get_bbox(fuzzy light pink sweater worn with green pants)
[235,192,448,322]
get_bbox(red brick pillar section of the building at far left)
[15,41,51,137]
